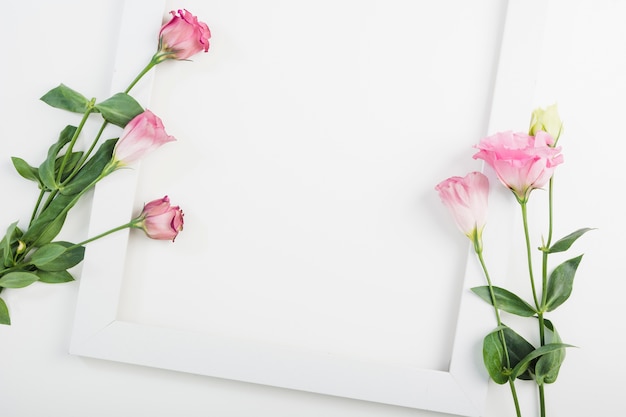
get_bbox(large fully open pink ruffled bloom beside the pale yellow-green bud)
[474,131,563,203]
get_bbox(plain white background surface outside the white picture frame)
[0,1,626,417]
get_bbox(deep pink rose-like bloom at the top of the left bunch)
[157,10,211,62]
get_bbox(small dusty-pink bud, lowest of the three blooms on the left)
[132,196,184,242]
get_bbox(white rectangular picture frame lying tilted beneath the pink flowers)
[70,0,546,416]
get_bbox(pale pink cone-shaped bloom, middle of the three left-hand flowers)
[113,110,176,167]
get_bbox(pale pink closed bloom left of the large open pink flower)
[435,172,489,252]
